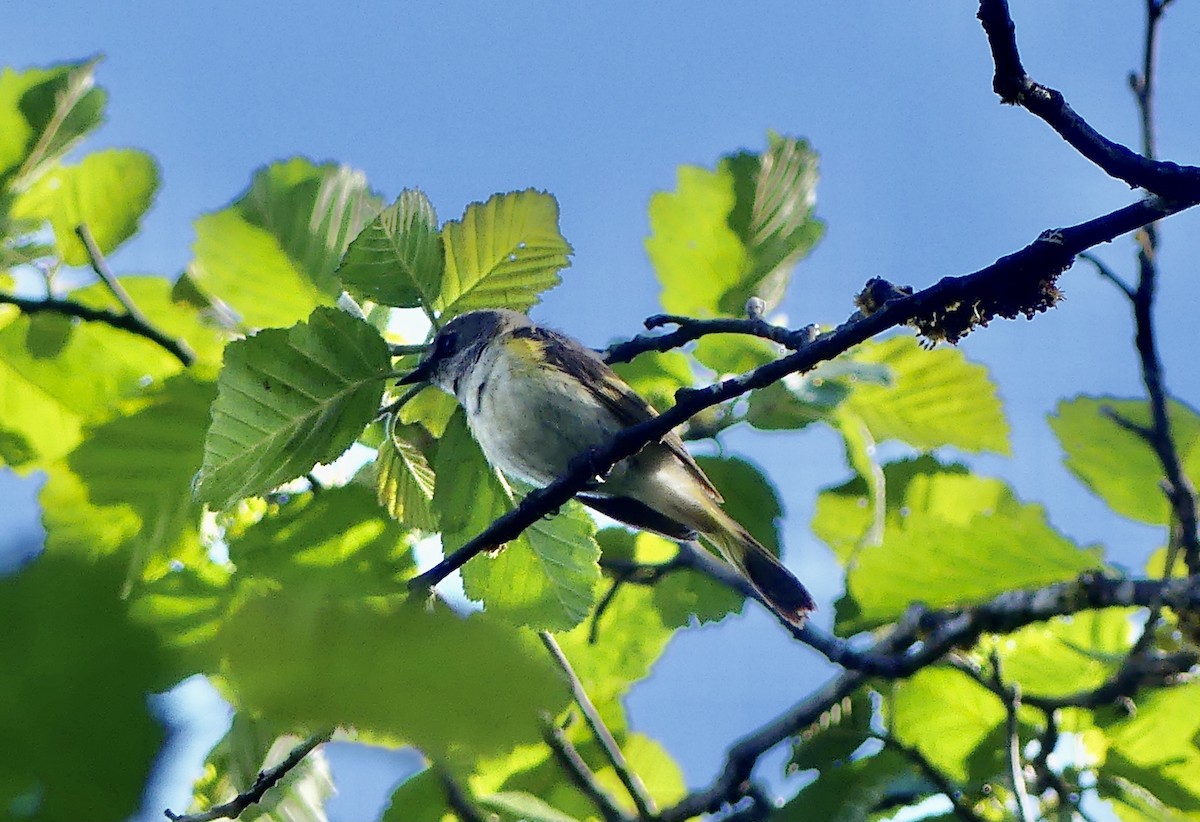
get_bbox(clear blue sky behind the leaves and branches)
[0,0,1200,818]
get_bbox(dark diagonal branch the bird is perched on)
[408,197,1188,592]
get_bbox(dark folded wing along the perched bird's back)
[512,326,722,503]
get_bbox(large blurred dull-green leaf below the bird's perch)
[221,588,568,760]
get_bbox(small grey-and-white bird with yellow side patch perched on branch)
[400,310,815,625]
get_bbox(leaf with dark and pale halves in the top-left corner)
[0,59,107,188]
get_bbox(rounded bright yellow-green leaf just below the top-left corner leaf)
[12,149,158,265]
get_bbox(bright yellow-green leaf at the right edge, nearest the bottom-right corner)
[1097,682,1200,814]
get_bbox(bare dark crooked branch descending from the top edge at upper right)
[978,0,1200,202]
